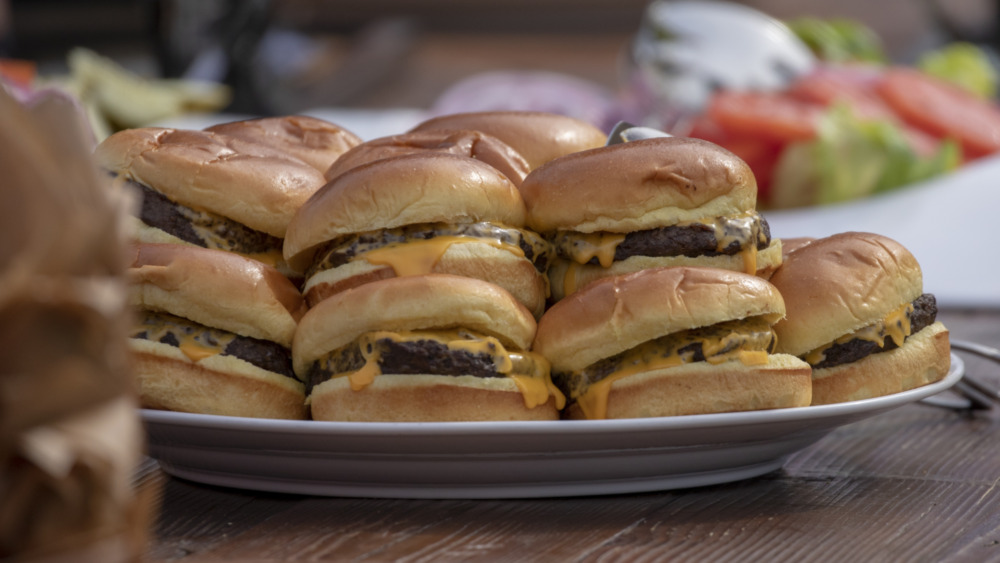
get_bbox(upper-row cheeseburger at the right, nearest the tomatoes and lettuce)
[521,137,781,300]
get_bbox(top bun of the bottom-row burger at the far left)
[128,244,306,347]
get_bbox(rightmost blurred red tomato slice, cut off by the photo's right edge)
[877,68,1000,159]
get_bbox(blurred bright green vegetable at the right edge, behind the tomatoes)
[917,43,997,99]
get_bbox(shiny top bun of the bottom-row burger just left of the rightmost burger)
[533,267,785,371]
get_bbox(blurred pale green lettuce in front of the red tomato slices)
[772,104,961,207]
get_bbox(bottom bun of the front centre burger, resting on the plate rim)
[309,374,559,422]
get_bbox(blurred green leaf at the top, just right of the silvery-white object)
[785,17,886,64]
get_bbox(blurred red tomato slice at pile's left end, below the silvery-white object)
[706,91,824,143]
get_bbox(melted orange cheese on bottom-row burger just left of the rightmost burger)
[570,319,773,419]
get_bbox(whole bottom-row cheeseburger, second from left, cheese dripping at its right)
[292,274,563,422]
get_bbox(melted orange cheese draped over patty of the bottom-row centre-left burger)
[334,330,566,409]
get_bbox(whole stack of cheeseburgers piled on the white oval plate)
[96,112,949,421]
